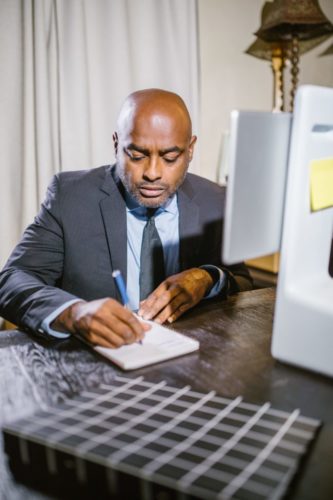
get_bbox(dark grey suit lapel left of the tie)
[100,169,127,282]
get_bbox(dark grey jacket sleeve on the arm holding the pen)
[0,176,77,330]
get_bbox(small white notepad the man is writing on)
[93,321,200,370]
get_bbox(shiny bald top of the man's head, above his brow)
[117,89,192,139]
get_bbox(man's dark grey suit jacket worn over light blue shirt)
[0,166,249,330]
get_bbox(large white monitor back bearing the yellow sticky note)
[272,86,333,376]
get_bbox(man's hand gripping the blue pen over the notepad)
[51,298,150,347]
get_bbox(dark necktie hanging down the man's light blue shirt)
[139,208,165,300]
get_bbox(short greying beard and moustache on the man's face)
[117,163,187,208]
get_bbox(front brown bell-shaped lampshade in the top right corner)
[255,0,333,42]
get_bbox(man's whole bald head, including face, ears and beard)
[113,89,196,207]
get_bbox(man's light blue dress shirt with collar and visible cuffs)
[39,193,226,338]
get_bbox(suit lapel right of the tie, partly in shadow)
[178,178,200,271]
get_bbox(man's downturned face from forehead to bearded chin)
[114,112,196,208]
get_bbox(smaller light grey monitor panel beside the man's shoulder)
[222,111,291,264]
